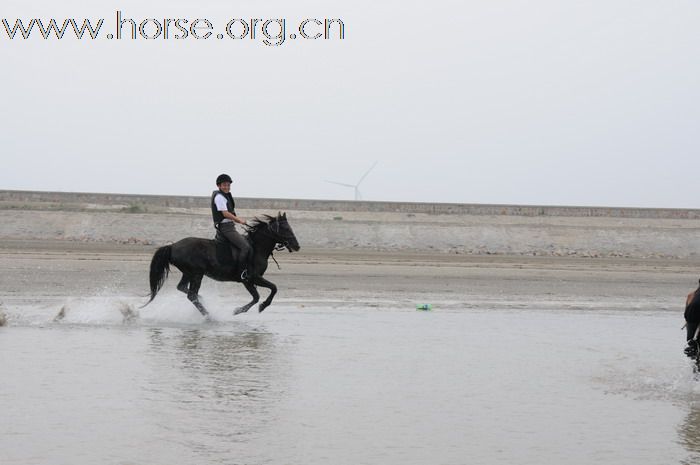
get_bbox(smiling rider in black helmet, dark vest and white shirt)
[211,174,253,281]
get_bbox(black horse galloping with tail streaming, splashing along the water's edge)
[144,213,299,317]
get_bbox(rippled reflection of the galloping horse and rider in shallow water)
[147,328,289,457]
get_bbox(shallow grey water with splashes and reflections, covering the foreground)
[0,298,700,465]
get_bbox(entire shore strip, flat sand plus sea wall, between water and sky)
[0,191,700,313]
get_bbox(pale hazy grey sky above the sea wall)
[0,0,700,208]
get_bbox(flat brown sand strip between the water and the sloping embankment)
[0,239,700,321]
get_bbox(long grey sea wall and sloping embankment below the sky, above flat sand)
[0,191,700,259]
